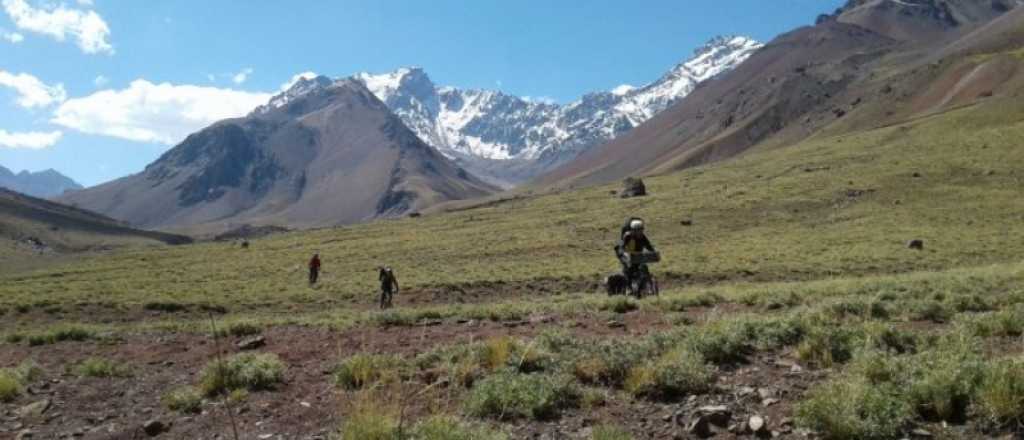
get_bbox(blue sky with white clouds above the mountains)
[0,0,843,185]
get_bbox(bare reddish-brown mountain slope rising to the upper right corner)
[534,0,1022,187]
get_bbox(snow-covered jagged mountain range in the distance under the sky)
[256,37,762,185]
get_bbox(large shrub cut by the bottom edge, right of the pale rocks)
[796,378,910,440]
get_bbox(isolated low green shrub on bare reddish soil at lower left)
[200,353,285,396]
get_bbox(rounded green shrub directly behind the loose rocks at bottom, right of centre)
[625,349,714,400]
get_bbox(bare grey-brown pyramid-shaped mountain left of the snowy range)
[60,77,493,232]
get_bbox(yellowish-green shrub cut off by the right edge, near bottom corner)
[977,359,1024,426]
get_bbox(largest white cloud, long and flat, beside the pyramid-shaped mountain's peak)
[51,79,270,145]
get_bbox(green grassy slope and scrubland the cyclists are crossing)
[0,94,1024,439]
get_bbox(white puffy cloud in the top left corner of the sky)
[3,0,114,54]
